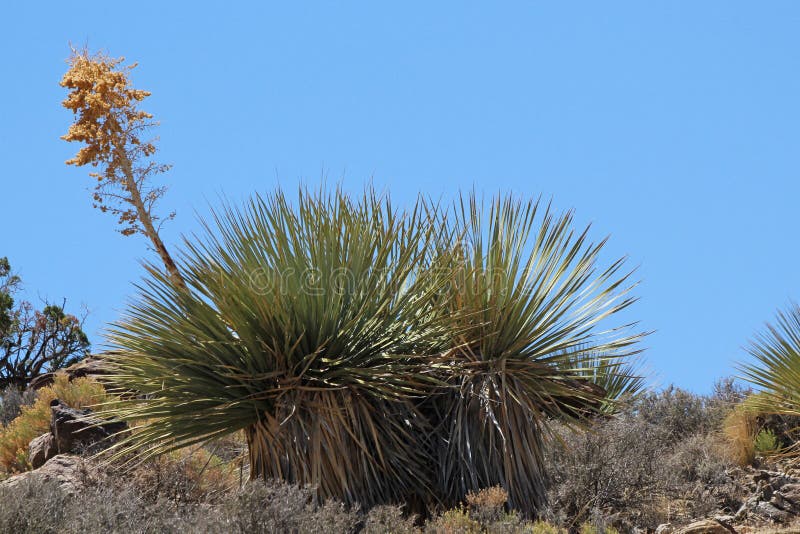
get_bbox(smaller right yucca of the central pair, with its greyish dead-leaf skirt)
[427,194,641,513]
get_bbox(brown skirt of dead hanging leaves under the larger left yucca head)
[246,389,431,506]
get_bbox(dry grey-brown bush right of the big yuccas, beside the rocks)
[547,388,753,528]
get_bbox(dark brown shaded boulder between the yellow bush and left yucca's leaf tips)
[50,399,128,453]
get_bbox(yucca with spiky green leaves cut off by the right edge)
[740,303,800,460]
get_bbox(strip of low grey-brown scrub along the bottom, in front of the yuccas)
[0,476,576,534]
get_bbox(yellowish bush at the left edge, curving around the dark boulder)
[0,375,108,472]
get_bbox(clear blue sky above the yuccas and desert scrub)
[0,1,800,391]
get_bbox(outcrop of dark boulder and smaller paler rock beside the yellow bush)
[28,399,128,469]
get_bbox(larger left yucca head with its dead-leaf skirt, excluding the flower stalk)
[101,190,452,506]
